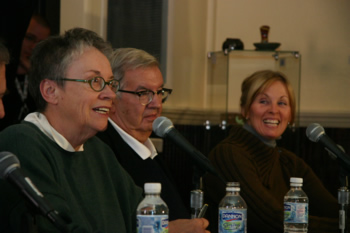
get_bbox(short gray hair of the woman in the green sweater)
[29,28,113,111]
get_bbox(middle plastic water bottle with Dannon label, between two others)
[219,182,247,233]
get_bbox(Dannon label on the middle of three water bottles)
[219,209,247,233]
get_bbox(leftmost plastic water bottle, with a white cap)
[136,183,169,233]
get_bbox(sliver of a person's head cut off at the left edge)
[0,41,10,119]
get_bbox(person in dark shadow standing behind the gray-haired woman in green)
[0,14,51,131]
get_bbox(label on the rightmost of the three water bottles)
[284,202,309,223]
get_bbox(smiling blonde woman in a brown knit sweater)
[203,70,339,233]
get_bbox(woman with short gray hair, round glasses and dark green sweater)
[0,28,142,232]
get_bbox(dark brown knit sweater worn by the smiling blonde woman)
[204,126,339,233]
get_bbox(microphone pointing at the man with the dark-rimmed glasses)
[152,116,226,183]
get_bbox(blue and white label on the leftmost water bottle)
[136,215,169,233]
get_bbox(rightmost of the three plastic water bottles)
[284,177,309,233]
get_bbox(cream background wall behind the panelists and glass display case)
[60,0,350,127]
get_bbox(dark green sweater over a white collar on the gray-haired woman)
[0,122,142,233]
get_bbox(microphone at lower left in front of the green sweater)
[0,151,68,232]
